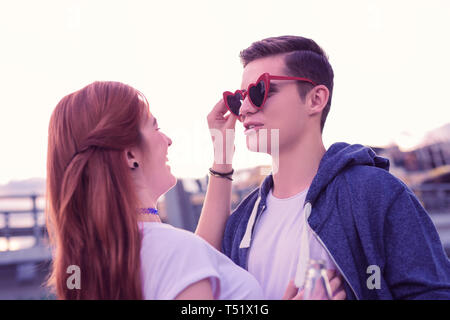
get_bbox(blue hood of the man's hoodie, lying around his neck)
[259,142,389,206]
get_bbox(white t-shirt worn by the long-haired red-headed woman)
[140,222,263,300]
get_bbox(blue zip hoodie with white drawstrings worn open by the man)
[222,142,450,299]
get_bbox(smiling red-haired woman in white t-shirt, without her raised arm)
[46,82,263,299]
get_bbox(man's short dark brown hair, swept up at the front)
[240,36,334,132]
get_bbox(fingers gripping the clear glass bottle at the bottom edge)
[283,270,347,300]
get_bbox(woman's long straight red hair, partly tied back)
[46,82,149,299]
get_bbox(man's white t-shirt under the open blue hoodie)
[248,189,336,300]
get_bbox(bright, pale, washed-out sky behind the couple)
[0,0,450,183]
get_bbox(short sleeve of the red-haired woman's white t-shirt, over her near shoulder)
[141,222,220,299]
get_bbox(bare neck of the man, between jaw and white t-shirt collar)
[272,132,326,199]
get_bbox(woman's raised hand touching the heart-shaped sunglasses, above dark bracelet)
[207,99,238,172]
